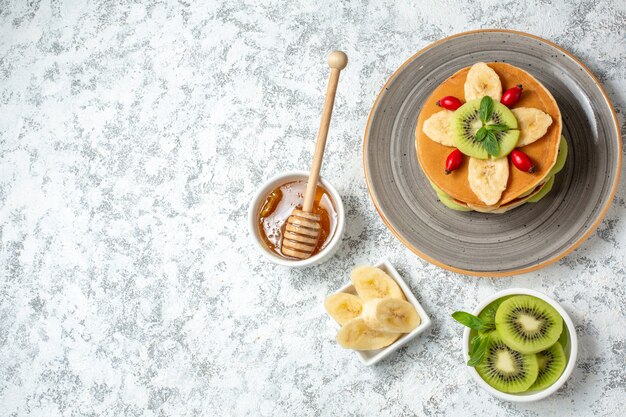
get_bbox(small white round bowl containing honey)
[248,171,346,268]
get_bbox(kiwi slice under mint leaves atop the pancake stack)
[452,99,519,159]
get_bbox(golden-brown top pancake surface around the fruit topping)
[415,62,563,209]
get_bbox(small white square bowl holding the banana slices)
[333,260,431,366]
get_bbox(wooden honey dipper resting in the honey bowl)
[281,51,348,259]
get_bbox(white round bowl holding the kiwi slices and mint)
[463,288,578,402]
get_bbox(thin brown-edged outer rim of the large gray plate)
[362,29,622,278]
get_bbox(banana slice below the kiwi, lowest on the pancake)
[467,156,509,206]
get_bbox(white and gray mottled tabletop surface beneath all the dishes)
[0,0,626,416]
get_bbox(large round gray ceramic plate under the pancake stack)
[363,30,621,276]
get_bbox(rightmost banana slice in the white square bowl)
[362,298,422,333]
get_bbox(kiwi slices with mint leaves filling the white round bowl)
[452,292,576,401]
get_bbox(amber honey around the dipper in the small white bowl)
[258,181,337,259]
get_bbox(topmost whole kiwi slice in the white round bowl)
[496,295,563,353]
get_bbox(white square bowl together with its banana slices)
[324,260,431,366]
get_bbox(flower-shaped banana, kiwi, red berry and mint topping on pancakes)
[422,62,552,208]
